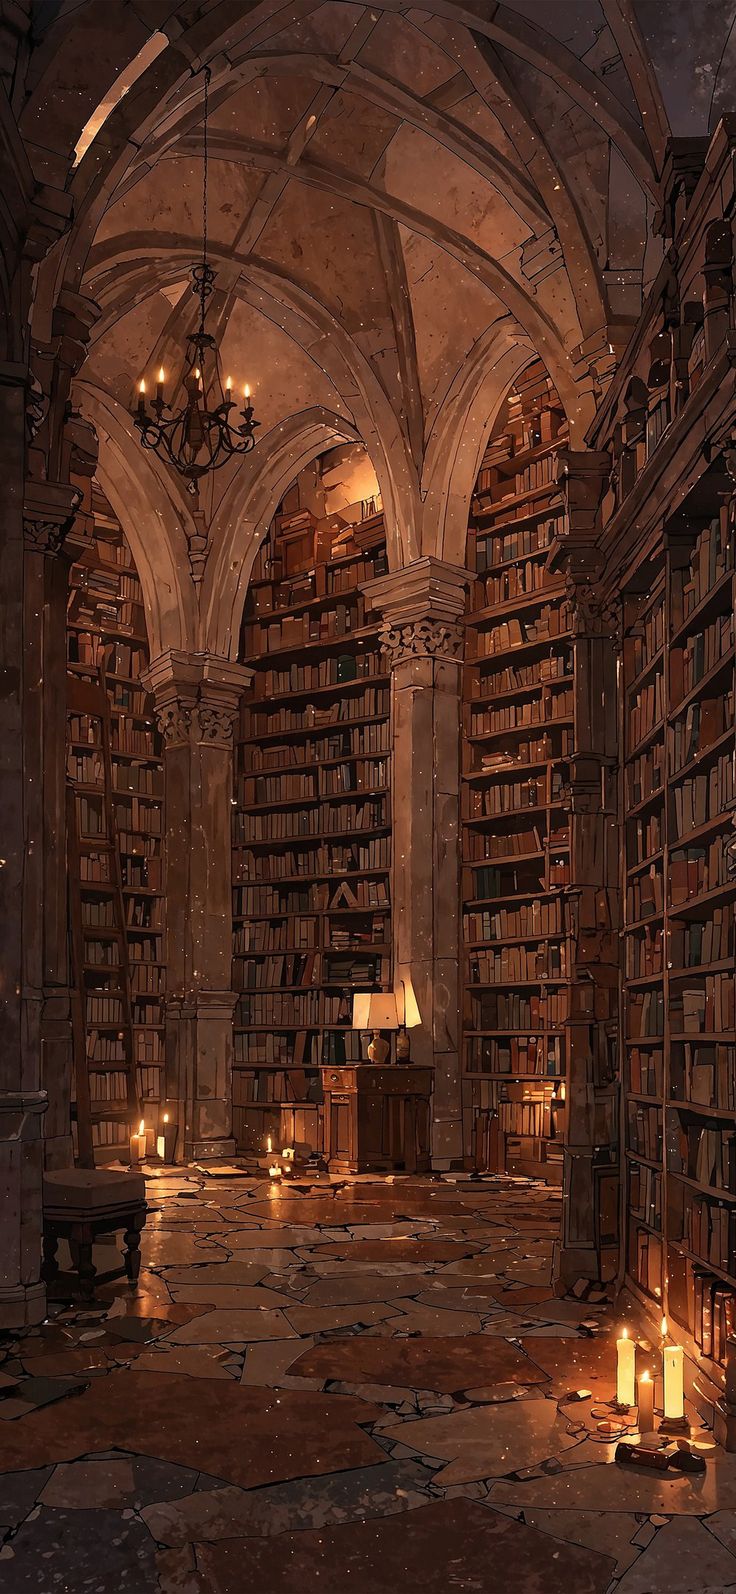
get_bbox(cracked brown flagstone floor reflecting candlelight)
[0,1170,736,1594]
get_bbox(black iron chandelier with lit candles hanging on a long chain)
[132,67,260,493]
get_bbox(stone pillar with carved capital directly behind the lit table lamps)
[363,558,470,1168]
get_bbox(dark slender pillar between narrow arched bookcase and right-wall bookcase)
[551,450,621,1290]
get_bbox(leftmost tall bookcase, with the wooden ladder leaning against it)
[67,486,164,1162]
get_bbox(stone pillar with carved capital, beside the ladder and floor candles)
[143,650,253,1159]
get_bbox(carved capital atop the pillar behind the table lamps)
[363,558,473,668]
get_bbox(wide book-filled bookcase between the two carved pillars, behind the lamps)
[233,504,392,1152]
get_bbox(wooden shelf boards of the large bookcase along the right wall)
[621,501,736,1382]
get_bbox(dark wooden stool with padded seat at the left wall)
[41,1168,148,1301]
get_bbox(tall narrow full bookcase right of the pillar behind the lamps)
[462,363,574,1183]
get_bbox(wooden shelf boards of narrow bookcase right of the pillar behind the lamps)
[460,367,575,1183]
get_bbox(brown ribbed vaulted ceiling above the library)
[19,0,736,573]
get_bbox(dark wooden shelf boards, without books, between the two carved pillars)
[233,503,390,1128]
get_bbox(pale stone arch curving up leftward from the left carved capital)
[75,381,199,657]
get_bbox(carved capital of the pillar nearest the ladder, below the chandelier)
[140,649,253,748]
